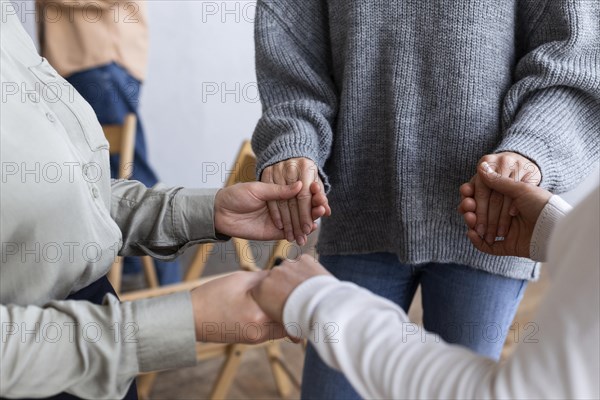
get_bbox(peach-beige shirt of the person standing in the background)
[36,0,148,81]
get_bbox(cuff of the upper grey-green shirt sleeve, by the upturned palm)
[173,189,230,242]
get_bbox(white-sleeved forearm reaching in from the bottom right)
[284,277,497,399]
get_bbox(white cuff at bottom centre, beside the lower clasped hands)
[283,275,340,339]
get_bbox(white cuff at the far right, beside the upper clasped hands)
[529,195,572,261]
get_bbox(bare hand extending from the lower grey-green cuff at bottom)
[192,271,285,344]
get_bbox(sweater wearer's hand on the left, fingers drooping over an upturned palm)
[261,158,331,246]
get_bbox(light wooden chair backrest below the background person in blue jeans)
[102,114,137,179]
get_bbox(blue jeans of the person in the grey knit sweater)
[302,253,527,400]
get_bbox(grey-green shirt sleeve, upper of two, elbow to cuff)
[111,180,229,260]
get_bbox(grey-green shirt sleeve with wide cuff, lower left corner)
[0,292,196,399]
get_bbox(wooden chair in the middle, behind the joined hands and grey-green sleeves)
[129,141,300,399]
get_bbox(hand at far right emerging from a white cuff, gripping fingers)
[458,162,552,257]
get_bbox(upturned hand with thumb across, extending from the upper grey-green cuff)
[215,182,327,240]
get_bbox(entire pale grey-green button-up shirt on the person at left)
[0,5,218,399]
